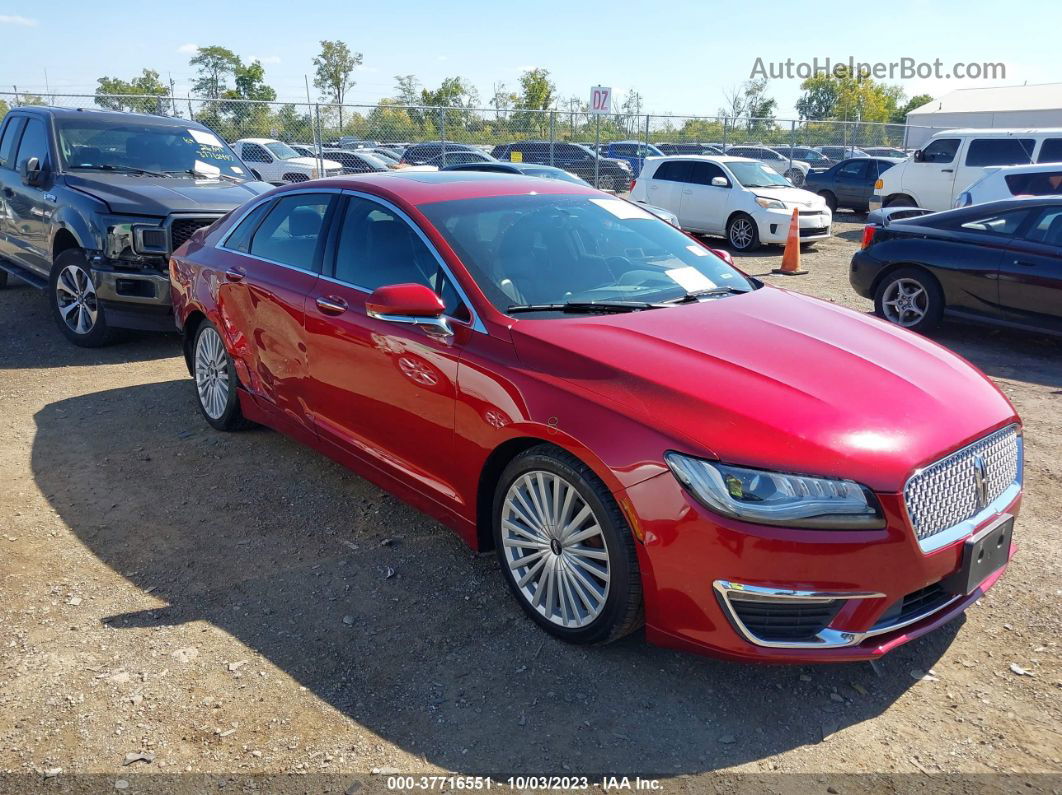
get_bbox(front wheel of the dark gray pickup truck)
[48,248,115,348]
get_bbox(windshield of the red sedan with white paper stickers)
[419,194,753,317]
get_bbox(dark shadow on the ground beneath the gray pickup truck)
[0,279,181,371]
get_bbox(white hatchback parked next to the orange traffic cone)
[631,155,834,252]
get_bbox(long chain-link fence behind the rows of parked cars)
[0,92,955,191]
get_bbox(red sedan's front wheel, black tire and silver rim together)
[492,445,643,643]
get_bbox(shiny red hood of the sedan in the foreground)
[512,287,1016,492]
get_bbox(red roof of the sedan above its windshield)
[277,171,606,205]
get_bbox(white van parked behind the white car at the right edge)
[870,128,1062,210]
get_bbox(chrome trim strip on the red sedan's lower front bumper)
[713,580,963,649]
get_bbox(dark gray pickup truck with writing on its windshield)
[0,106,271,347]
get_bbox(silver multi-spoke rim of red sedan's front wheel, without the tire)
[501,470,611,628]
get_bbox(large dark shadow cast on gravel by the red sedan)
[32,381,961,777]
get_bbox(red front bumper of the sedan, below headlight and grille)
[622,473,1021,663]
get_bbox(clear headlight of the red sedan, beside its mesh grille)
[664,452,885,530]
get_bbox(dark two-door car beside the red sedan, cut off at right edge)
[849,196,1062,334]
